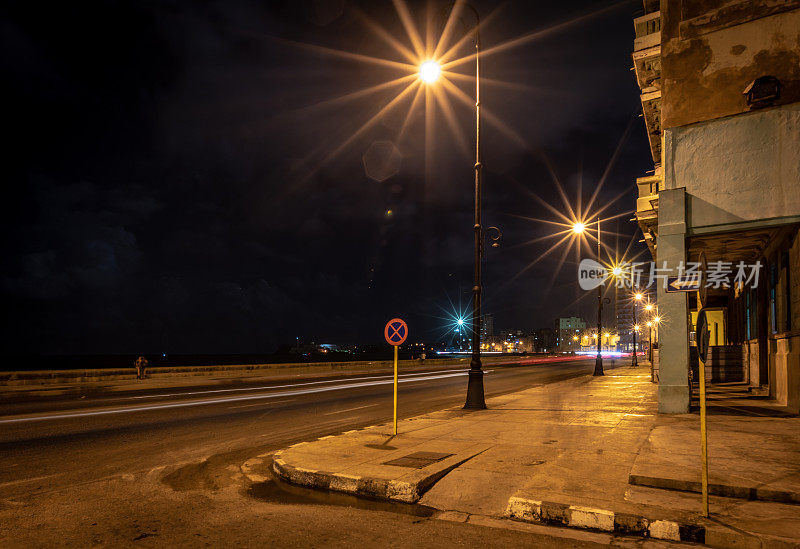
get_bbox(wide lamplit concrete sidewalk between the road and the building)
[262,366,800,547]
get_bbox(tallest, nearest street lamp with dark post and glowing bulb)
[419,3,486,410]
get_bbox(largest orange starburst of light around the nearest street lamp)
[282,0,626,180]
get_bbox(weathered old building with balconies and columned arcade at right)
[633,0,800,413]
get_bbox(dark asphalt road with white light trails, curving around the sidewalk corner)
[0,359,636,546]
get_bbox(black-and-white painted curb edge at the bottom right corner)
[505,497,800,549]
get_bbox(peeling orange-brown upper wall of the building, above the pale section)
[661,0,800,128]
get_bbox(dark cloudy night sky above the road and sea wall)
[1,0,653,353]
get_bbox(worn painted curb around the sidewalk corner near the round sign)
[272,442,483,503]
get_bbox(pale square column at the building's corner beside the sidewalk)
[656,188,689,414]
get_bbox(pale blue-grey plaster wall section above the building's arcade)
[664,103,800,228]
